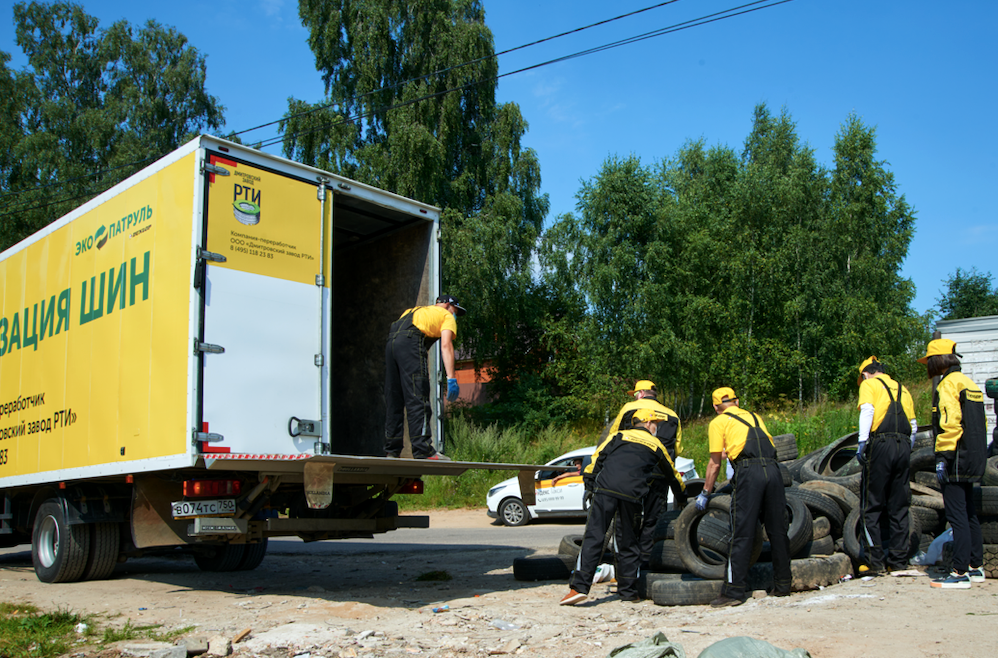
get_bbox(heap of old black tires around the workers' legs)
[513,428,998,605]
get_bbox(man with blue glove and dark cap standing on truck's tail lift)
[385,295,466,460]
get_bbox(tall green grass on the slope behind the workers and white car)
[396,381,932,510]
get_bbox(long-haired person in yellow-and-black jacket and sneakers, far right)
[918,338,988,589]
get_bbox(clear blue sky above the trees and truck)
[0,0,998,313]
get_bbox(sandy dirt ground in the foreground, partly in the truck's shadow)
[0,510,998,658]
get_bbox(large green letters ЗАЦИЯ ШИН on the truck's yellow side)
[0,251,150,357]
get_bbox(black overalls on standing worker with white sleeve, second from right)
[860,378,911,571]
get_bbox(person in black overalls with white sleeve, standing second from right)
[856,356,918,576]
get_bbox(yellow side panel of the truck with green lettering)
[0,153,196,477]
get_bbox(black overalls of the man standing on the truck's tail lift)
[385,309,437,459]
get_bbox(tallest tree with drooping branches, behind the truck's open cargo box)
[282,0,548,410]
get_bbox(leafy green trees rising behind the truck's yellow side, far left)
[0,2,223,248]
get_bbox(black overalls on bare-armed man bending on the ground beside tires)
[721,414,792,601]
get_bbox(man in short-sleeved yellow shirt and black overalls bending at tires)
[696,387,791,608]
